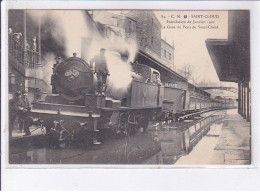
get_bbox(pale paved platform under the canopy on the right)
[212,109,251,165]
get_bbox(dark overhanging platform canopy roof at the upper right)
[206,10,250,82]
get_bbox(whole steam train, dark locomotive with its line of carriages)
[26,54,225,144]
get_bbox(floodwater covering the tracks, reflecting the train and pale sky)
[9,111,226,164]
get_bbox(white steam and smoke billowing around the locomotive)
[28,10,137,98]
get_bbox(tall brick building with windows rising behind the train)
[126,10,188,90]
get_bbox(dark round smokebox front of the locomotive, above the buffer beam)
[51,53,95,101]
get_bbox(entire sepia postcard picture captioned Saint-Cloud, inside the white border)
[5,9,252,168]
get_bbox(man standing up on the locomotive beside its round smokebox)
[90,48,109,94]
